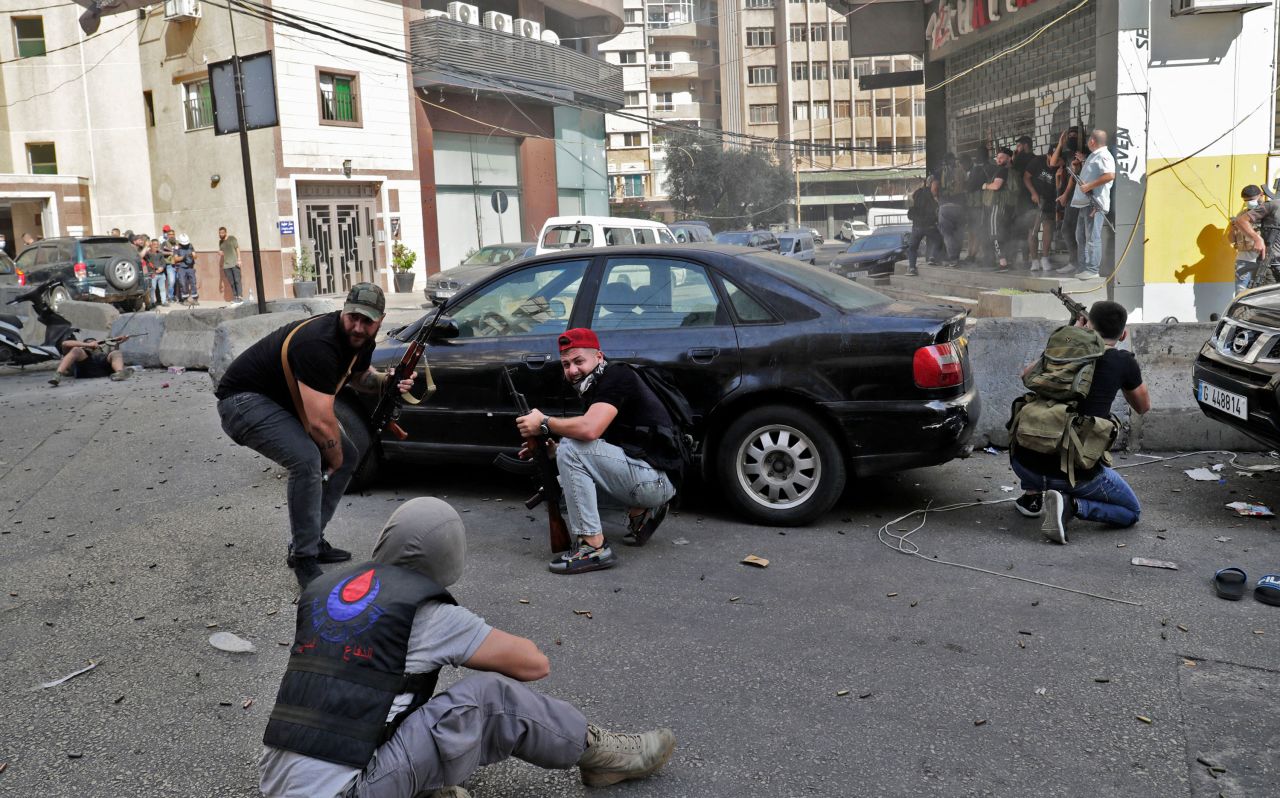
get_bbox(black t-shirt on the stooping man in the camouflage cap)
[214,310,374,415]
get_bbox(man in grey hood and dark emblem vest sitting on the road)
[260,498,676,798]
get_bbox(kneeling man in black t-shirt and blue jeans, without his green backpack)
[1009,301,1151,543]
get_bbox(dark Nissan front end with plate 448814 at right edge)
[1192,286,1280,448]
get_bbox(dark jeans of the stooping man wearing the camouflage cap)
[218,393,360,557]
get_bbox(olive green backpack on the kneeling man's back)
[1009,325,1119,485]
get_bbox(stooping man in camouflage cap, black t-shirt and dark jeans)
[214,283,413,587]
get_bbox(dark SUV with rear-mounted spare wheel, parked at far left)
[15,236,146,311]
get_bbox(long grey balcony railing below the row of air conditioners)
[410,18,625,110]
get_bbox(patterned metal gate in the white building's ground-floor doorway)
[298,183,378,293]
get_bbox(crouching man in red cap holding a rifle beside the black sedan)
[516,328,681,574]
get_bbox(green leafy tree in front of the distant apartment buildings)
[666,133,795,229]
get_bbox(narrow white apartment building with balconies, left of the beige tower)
[599,0,721,218]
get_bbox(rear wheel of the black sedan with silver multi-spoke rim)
[716,405,846,526]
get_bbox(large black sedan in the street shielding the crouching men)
[338,245,979,525]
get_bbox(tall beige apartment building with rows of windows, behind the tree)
[719,0,924,234]
